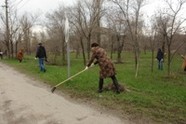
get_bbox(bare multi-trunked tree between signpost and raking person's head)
[69,0,104,64]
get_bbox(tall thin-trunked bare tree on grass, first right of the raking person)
[111,0,145,77]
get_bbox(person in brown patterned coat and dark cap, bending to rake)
[85,43,120,93]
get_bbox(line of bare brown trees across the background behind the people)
[0,0,186,77]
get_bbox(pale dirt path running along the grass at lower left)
[0,63,131,124]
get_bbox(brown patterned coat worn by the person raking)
[87,47,116,78]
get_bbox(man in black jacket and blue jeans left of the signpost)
[35,43,47,72]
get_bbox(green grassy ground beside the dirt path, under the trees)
[2,54,186,124]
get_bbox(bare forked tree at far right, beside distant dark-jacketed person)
[154,0,186,76]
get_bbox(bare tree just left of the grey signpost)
[46,6,66,65]
